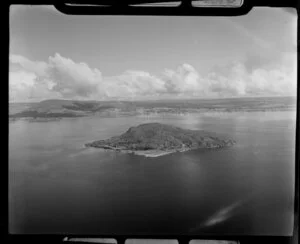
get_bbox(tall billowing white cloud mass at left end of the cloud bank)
[10,53,102,98]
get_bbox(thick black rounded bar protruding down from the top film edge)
[54,0,252,16]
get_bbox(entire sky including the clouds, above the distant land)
[9,5,297,102]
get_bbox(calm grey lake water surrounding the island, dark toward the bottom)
[9,111,296,235]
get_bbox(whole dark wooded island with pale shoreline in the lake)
[85,123,235,157]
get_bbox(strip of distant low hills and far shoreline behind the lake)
[9,97,296,118]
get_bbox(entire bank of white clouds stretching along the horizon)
[9,53,296,101]
